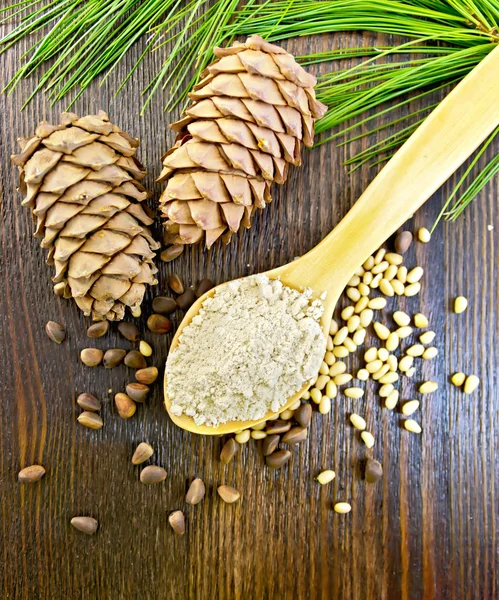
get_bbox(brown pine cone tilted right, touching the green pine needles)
[159,36,326,247]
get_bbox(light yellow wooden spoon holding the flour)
[164,47,499,435]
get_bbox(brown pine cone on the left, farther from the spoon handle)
[12,111,159,321]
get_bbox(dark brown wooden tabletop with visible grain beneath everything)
[0,18,499,600]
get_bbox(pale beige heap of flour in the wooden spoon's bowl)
[166,275,326,426]
